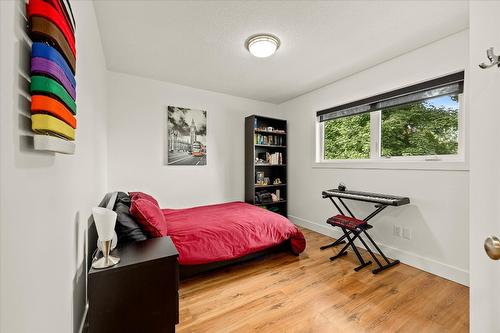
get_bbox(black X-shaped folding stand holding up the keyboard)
[320,197,399,274]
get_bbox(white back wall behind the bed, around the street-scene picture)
[108,73,277,208]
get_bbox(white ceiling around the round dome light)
[95,1,469,103]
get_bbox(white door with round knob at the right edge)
[469,1,500,333]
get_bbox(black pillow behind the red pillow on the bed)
[113,192,148,244]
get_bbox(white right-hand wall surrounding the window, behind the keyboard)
[280,31,469,284]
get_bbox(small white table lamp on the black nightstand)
[92,207,120,269]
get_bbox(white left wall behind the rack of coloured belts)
[0,1,107,333]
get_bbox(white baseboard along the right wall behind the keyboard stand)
[288,215,469,286]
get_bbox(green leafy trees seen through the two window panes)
[324,95,459,160]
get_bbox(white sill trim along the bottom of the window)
[312,158,469,171]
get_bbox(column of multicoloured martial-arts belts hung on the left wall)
[26,0,77,154]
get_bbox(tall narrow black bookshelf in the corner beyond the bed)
[245,115,288,217]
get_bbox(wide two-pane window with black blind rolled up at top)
[317,72,464,162]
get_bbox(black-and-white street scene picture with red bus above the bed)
[165,106,207,165]
